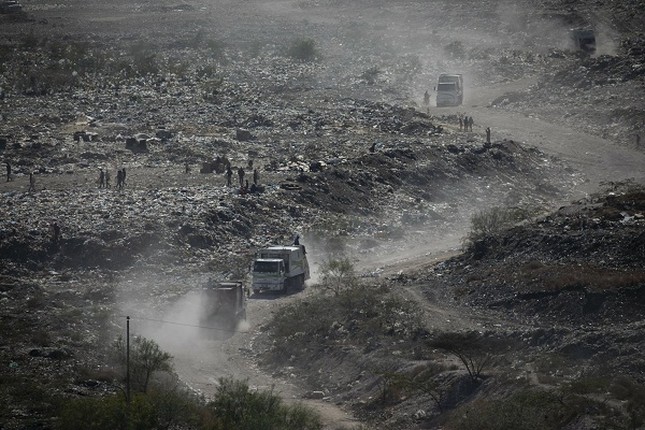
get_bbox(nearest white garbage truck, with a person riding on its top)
[251,245,309,294]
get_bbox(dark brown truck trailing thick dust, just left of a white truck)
[201,280,246,330]
